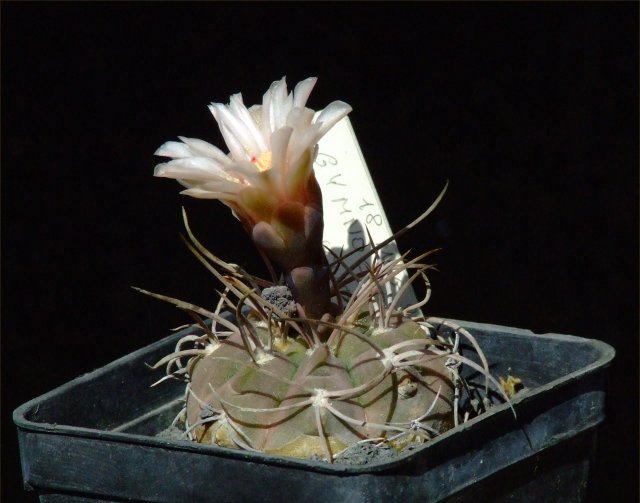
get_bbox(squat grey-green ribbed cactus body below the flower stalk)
[187,321,453,458]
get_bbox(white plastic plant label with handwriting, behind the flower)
[314,117,416,306]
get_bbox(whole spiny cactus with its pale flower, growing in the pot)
[143,79,500,462]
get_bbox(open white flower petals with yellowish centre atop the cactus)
[154,78,351,226]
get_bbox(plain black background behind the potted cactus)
[2,2,638,502]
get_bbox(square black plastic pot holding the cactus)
[13,322,614,503]
